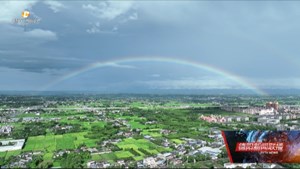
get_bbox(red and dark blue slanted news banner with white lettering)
[222,130,300,163]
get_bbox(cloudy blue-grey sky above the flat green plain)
[0,0,300,92]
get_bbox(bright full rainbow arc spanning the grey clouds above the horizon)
[40,57,267,95]
